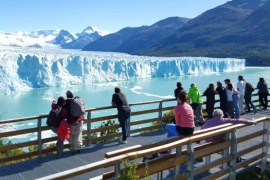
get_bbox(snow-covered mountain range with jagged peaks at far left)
[0,26,107,49]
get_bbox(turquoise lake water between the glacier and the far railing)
[0,67,270,119]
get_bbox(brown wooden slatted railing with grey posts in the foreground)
[36,117,270,180]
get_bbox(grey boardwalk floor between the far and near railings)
[0,110,270,180]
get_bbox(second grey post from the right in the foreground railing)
[229,129,237,180]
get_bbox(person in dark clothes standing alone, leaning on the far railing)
[112,87,131,144]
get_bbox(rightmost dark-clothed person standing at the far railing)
[257,77,269,110]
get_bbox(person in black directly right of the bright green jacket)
[203,83,216,118]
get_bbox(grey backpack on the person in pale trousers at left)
[69,96,85,117]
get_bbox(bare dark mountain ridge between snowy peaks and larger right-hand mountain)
[83,17,189,54]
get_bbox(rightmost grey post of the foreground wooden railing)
[261,120,269,173]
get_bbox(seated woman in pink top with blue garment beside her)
[166,91,195,137]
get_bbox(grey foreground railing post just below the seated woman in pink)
[186,142,194,180]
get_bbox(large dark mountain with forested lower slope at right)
[138,0,270,66]
